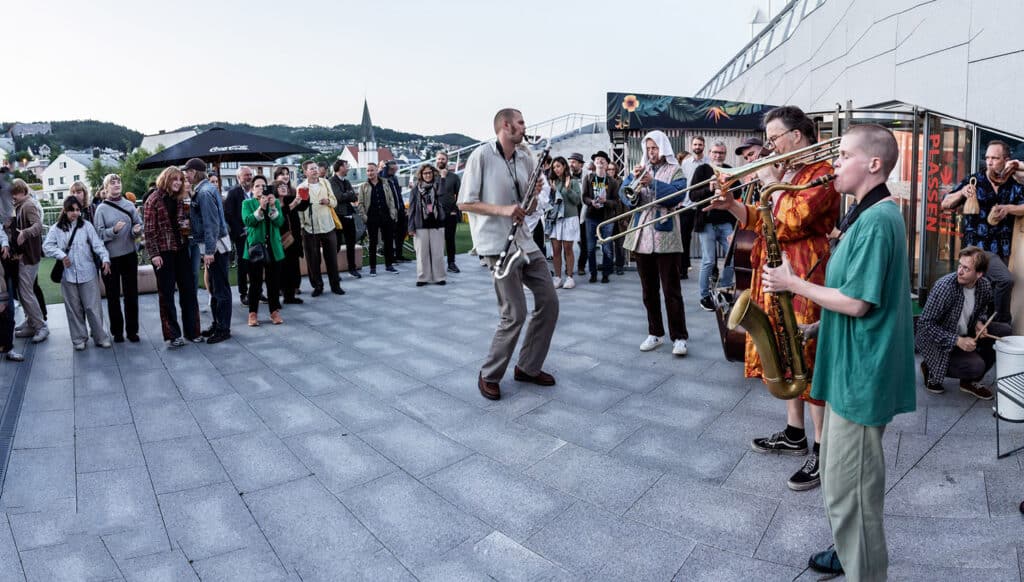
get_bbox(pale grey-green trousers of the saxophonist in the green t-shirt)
[818,403,889,582]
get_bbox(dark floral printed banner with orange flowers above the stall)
[608,93,775,133]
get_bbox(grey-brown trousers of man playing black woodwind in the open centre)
[480,251,558,382]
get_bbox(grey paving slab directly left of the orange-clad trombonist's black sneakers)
[611,424,744,484]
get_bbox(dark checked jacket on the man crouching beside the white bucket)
[914,273,992,383]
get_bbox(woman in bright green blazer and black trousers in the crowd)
[242,176,285,327]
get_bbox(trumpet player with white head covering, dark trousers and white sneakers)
[618,131,689,356]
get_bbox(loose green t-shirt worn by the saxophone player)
[811,202,915,426]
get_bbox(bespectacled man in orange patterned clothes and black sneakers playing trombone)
[708,106,840,491]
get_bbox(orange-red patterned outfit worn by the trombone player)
[743,162,840,400]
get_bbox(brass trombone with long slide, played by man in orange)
[597,137,840,244]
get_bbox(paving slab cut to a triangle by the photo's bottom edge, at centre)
[416,532,579,582]
